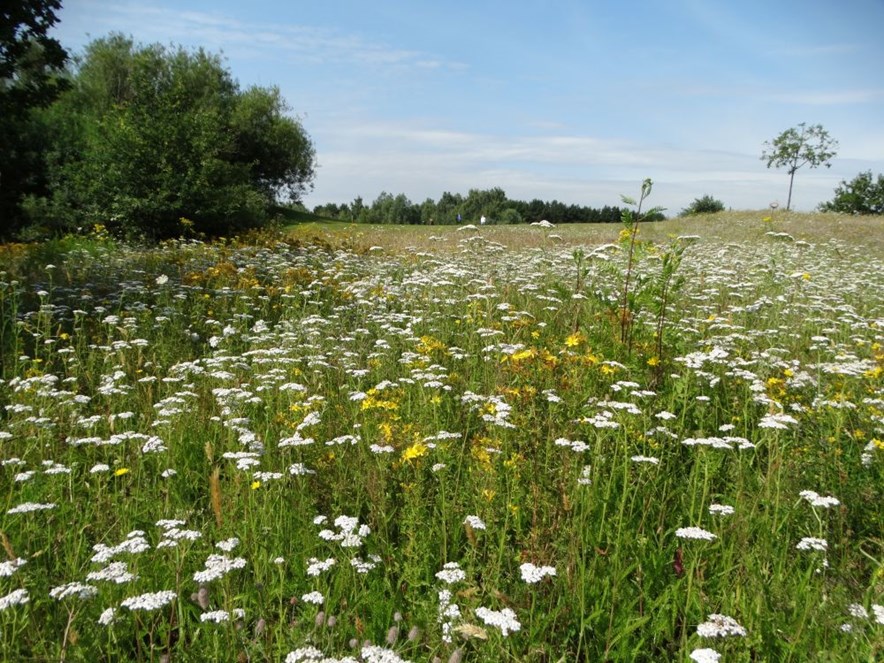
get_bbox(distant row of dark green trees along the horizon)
[313,187,636,226]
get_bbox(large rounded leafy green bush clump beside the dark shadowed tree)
[23,35,315,239]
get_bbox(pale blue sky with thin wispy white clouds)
[55,0,884,213]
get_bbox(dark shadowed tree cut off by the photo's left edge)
[0,0,68,236]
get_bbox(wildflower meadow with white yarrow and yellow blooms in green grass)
[0,212,884,663]
